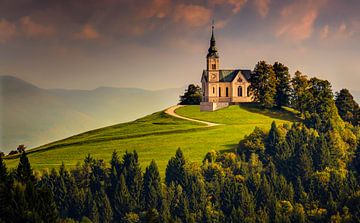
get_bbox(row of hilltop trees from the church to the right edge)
[250,61,360,125]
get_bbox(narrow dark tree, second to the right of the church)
[273,62,291,107]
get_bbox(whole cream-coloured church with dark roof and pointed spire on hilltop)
[200,25,253,111]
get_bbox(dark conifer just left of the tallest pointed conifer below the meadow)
[142,160,162,211]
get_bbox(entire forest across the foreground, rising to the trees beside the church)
[0,61,360,223]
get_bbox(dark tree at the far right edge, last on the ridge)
[335,89,360,125]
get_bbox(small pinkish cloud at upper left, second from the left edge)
[20,16,55,37]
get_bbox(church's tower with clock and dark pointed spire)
[206,24,219,82]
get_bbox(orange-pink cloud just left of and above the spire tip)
[173,4,212,27]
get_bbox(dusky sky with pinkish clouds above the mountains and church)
[0,0,360,90]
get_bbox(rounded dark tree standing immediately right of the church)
[250,61,277,108]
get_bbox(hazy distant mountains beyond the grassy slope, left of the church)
[0,76,183,152]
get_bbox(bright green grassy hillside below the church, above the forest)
[6,105,296,174]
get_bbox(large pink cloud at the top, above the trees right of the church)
[276,0,325,42]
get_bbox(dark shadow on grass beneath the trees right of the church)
[239,102,302,122]
